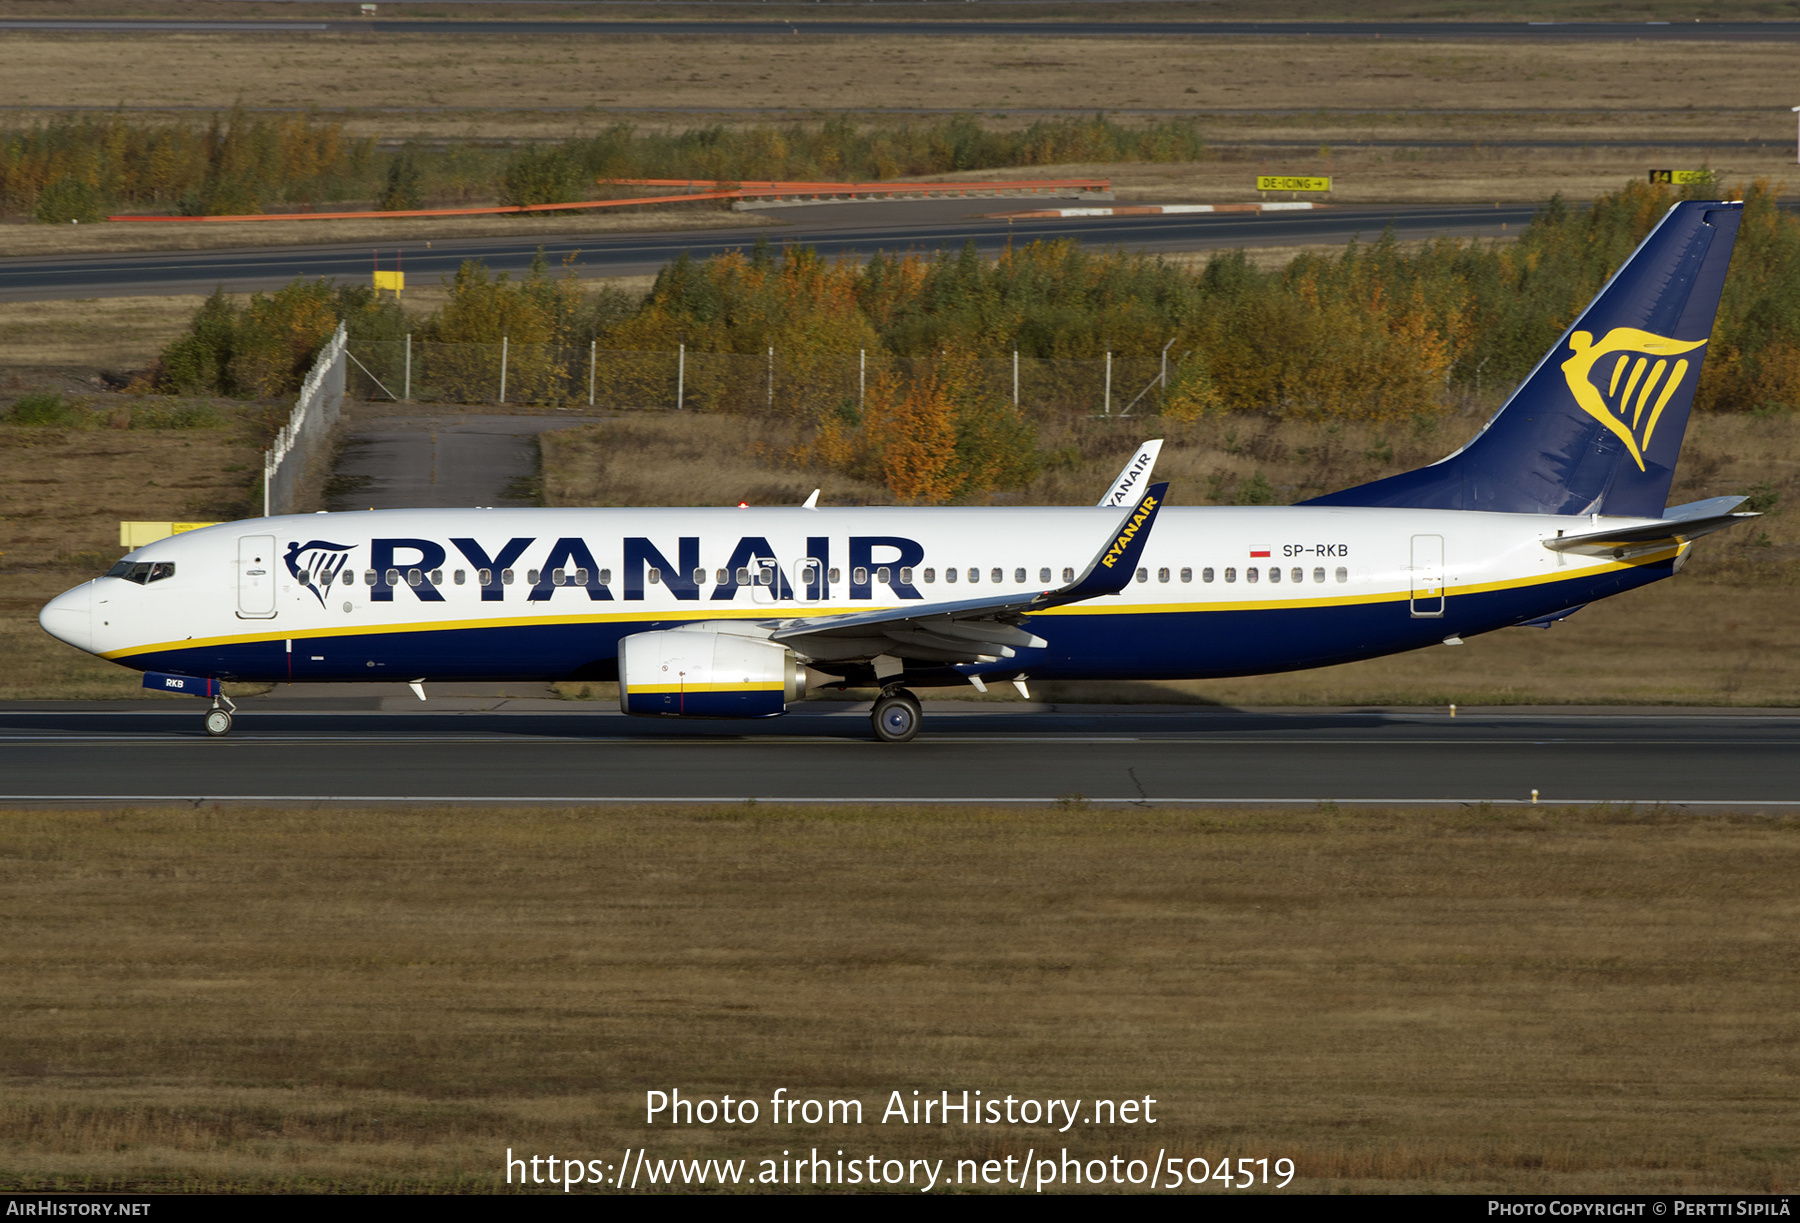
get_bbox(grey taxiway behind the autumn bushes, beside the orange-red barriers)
[0,198,1535,301]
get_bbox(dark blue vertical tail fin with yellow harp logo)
[1305,202,1744,517]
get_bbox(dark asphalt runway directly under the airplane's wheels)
[0,702,1800,807]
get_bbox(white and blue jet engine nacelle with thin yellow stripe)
[619,629,806,717]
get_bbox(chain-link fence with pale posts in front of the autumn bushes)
[349,340,1174,416]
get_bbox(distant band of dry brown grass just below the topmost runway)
[0,31,1800,125]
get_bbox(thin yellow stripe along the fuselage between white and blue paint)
[99,544,1688,661]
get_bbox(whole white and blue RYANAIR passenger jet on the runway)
[40,202,1750,742]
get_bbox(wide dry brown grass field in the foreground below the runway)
[0,805,1800,1192]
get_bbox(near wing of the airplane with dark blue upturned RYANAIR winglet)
[770,483,1168,663]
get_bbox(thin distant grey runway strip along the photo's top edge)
[0,19,1800,41]
